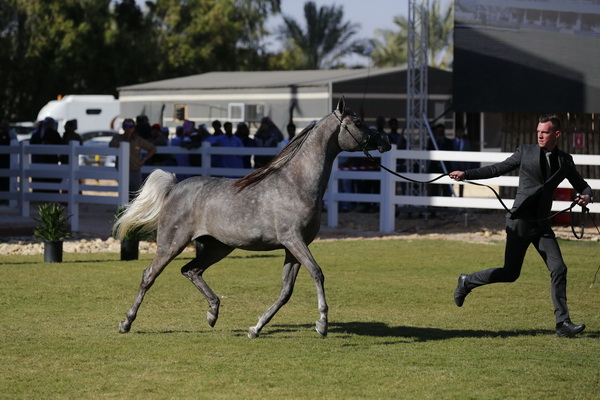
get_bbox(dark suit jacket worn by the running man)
[465,144,592,224]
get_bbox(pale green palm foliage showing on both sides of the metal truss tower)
[371,0,454,69]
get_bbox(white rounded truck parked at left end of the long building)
[37,94,121,135]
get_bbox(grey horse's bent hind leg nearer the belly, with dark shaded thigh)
[181,241,233,327]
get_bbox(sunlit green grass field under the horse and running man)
[0,240,600,399]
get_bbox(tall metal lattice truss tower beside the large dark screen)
[406,0,429,196]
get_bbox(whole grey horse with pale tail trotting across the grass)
[114,97,390,338]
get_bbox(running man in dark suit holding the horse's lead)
[449,115,592,337]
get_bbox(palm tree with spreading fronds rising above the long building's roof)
[278,1,360,69]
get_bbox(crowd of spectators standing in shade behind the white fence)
[0,115,470,212]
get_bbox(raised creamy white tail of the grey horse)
[113,169,177,240]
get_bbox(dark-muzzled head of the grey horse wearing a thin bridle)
[334,97,392,153]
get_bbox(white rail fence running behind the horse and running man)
[0,141,600,232]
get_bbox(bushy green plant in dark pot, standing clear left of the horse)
[33,203,71,263]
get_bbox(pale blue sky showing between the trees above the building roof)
[267,0,453,66]
